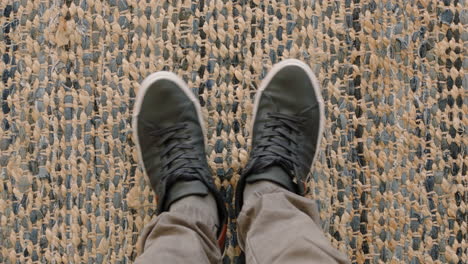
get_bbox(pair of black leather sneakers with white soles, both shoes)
[133,59,324,251]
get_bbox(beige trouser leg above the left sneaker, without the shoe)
[135,195,221,264]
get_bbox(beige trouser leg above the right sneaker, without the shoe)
[237,174,348,264]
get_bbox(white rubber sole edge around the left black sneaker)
[132,71,206,173]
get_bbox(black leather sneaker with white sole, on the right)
[236,59,325,213]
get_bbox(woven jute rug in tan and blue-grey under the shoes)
[0,0,468,263]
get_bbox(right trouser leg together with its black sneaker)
[235,60,346,264]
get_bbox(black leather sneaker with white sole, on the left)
[133,72,227,249]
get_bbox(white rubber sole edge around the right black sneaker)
[249,59,325,178]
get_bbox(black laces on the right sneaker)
[247,113,304,172]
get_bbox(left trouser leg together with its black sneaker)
[133,72,227,263]
